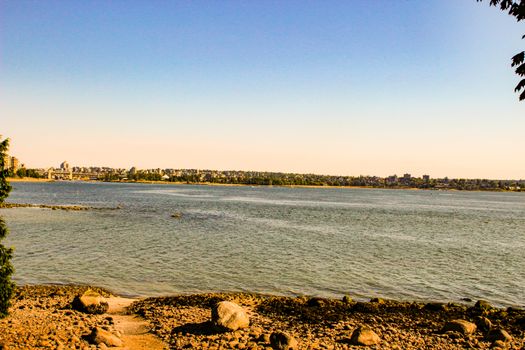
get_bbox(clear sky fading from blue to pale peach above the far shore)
[0,0,525,179]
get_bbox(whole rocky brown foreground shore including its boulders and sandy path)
[0,286,525,350]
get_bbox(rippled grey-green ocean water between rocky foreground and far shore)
[0,182,525,306]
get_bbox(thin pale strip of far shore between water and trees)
[8,177,523,193]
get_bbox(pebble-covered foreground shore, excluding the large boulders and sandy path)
[0,285,525,350]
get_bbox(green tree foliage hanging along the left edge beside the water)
[0,139,14,318]
